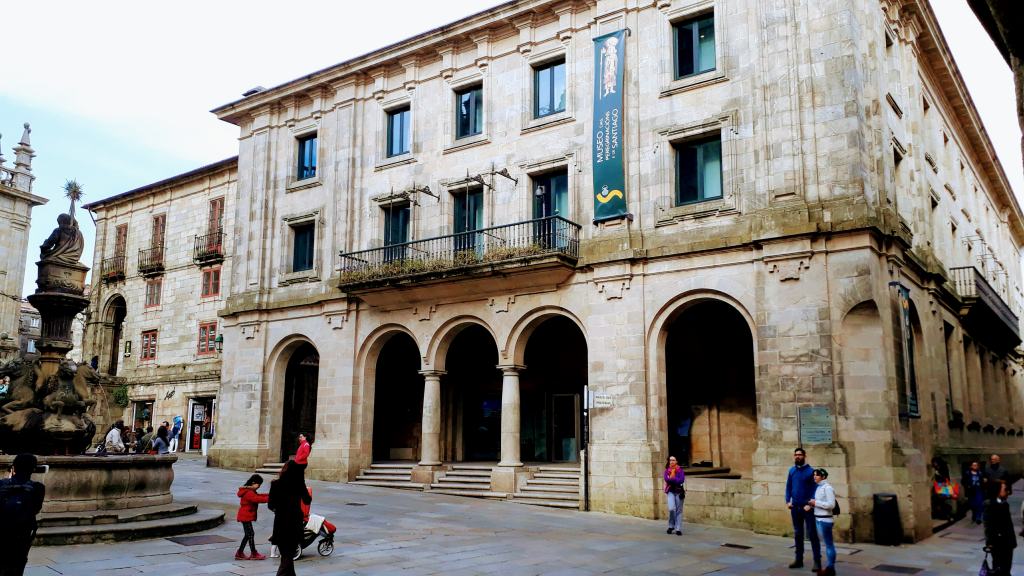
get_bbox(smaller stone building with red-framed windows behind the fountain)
[83,158,237,451]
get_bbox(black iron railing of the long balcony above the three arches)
[340,216,580,287]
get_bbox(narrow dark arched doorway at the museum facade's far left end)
[281,342,319,462]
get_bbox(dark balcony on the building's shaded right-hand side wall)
[949,266,1021,351]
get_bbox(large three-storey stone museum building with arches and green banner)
[205,0,1024,540]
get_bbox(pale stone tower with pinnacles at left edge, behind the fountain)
[0,123,46,362]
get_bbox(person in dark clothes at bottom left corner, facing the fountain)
[0,454,46,576]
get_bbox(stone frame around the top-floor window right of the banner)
[657,0,729,97]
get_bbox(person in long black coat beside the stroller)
[266,460,312,576]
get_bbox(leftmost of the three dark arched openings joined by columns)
[373,332,423,462]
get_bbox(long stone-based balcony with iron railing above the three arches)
[338,216,580,305]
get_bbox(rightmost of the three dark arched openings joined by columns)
[519,316,587,462]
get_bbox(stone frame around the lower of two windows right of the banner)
[654,111,742,225]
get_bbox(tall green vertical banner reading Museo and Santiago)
[593,30,627,222]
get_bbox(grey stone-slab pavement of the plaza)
[27,457,1024,576]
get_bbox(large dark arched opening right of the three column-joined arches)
[665,298,758,477]
